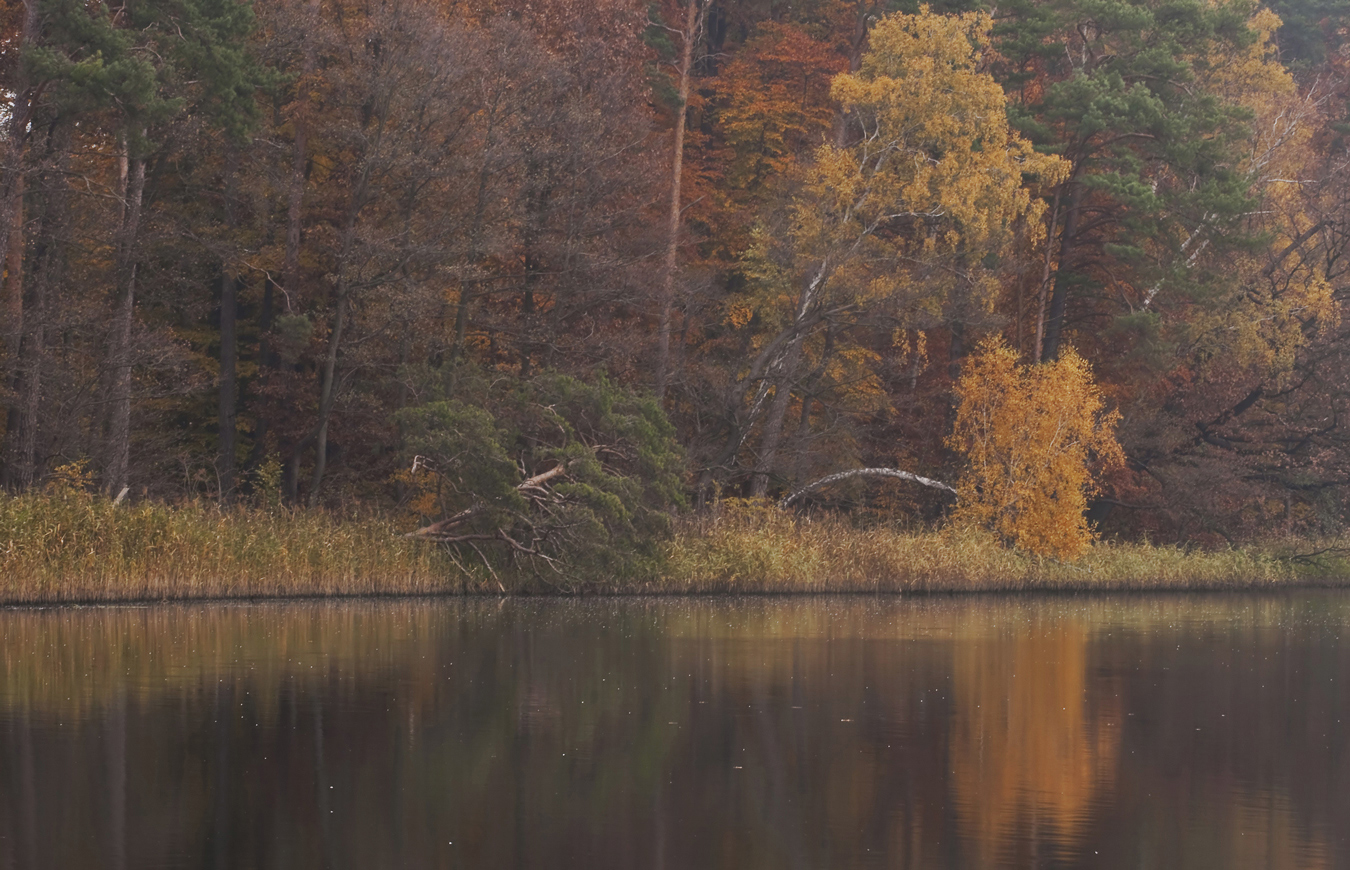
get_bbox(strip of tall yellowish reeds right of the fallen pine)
[655,507,1317,593]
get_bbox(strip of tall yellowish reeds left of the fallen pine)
[0,490,468,604]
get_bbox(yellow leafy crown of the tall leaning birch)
[724,7,1068,426]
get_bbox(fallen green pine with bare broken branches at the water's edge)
[398,369,682,582]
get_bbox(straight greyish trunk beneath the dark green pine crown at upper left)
[104,145,146,496]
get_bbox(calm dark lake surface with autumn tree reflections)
[0,593,1350,870]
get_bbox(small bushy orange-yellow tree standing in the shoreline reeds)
[948,338,1125,559]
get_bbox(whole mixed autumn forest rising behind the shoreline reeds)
[0,0,1350,567]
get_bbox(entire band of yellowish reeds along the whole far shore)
[0,493,1350,604]
